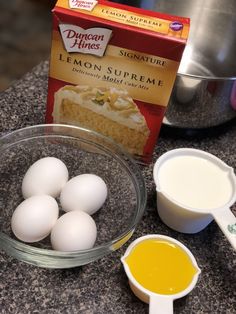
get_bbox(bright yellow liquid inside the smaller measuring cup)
[125,238,197,294]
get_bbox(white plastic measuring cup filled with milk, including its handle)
[153,148,236,250]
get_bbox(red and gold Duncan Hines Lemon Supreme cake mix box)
[46,0,189,163]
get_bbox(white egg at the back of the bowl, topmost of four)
[22,157,69,198]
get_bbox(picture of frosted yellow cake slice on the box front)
[52,85,150,156]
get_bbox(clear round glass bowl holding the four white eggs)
[0,124,146,268]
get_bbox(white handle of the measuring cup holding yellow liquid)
[149,295,173,314]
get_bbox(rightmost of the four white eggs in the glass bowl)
[60,174,107,215]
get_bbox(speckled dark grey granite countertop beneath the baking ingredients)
[0,62,236,314]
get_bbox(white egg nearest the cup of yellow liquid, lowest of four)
[51,210,97,252]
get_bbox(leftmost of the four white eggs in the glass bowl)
[11,195,59,243]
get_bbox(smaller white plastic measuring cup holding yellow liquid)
[121,234,201,314]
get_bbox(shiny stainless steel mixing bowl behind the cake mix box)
[111,0,236,129]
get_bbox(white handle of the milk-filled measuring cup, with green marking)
[212,208,236,250]
